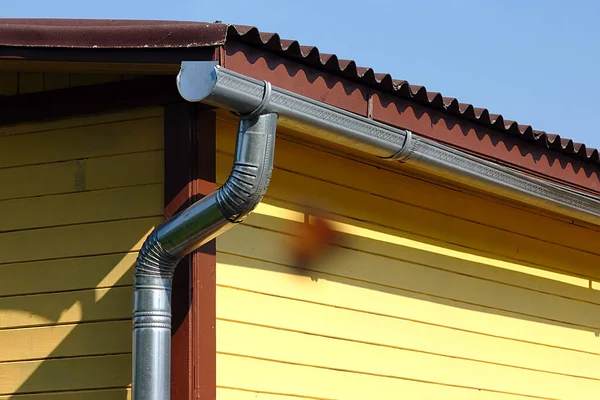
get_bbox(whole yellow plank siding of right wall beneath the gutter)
[216,121,600,400]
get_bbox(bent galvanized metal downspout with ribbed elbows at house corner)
[133,83,277,400]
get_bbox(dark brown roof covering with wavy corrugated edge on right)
[0,19,600,165]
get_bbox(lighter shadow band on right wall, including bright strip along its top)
[217,198,600,336]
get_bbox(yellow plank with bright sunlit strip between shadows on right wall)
[239,202,600,304]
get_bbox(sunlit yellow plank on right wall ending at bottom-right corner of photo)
[216,321,600,399]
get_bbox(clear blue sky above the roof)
[0,0,600,147]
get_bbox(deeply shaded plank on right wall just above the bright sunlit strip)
[217,154,600,278]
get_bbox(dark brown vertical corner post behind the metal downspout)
[164,102,216,400]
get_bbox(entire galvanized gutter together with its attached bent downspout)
[133,62,600,400]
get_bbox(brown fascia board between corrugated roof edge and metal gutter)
[221,39,600,194]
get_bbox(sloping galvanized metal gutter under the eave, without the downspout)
[178,61,600,225]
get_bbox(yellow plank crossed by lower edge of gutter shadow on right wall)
[217,253,600,354]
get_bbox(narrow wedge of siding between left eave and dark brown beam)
[0,71,131,96]
